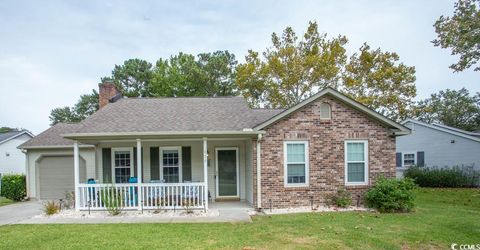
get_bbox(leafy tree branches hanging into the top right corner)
[432,0,480,72]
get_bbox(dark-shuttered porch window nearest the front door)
[160,147,182,183]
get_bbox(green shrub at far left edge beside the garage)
[1,174,27,201]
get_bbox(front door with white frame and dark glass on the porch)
[215,147,239,197]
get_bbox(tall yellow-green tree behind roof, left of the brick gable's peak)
[237,22,347,107]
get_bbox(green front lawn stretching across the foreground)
[0,189,480,249]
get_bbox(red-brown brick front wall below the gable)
[253,96,395,209]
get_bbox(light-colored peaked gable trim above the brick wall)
[254,87,410,135]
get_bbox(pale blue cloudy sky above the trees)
[0,0,480,134]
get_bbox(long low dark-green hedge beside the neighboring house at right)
[404,166,480,188]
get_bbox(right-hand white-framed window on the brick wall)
[345,140,368,185]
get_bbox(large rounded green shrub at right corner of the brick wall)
[365,177,416,213]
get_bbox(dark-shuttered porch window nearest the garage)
[112,148,134,183]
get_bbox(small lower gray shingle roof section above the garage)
[19,123,78,148]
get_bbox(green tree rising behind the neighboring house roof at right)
[415,88,480,131]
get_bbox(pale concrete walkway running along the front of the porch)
[17,202,253,224]
